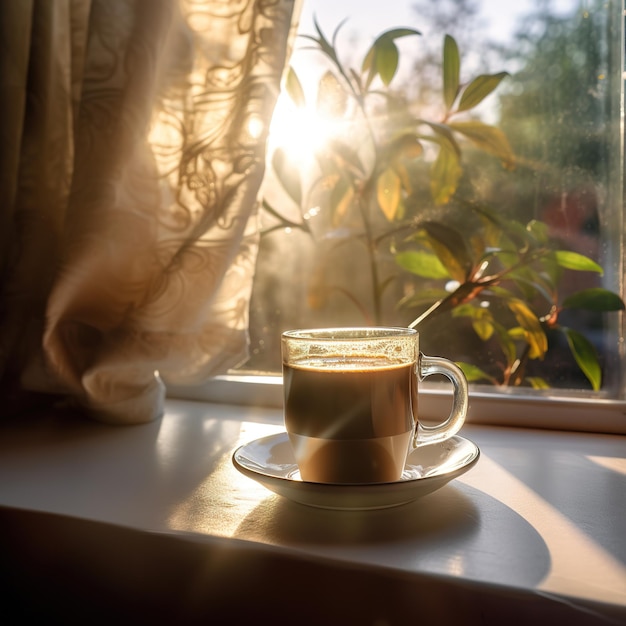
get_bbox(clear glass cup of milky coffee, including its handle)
[282,327,468,484]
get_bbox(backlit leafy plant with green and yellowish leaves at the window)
[264,19,624,390]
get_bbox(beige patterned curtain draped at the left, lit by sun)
[0,0,298,424]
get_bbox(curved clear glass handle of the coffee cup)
[413,353,469,448]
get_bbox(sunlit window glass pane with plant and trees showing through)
[242,0,624,397]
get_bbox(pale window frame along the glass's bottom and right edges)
[167,0,626,435]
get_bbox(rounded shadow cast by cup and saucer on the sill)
[234,483,551,587]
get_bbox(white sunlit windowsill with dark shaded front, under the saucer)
[0,399,626,624]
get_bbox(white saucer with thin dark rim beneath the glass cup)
[233,432,480,510]
